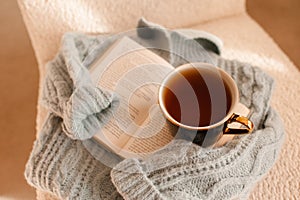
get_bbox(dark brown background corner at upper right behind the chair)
[246,0,300,68]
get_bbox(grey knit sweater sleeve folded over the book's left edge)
[41,34,119,140]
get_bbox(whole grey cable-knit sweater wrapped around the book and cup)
[25,20,284,199]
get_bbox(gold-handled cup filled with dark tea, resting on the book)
[159,63,254,147]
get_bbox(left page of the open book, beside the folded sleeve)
[91,37,173,153]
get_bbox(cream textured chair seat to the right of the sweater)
[31,14,300,199]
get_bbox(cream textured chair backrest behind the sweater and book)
[18,0,245,73]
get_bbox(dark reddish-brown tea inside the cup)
[162,67,232,127]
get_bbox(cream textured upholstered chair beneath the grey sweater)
[19,0,300,199]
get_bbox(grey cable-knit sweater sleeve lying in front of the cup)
[111,108,284,200]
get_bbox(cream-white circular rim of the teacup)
[158,62,239,130]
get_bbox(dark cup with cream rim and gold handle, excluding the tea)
[159,63,254,147]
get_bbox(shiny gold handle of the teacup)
[223,113,254,135]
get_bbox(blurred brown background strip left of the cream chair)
[0,0,38,199]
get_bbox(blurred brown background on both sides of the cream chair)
[0,0,300,199]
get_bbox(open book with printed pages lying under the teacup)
[90,37,249,158]
